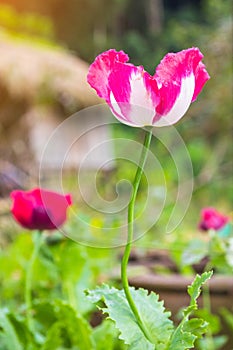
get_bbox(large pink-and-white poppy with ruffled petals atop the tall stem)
[87,48,209,127]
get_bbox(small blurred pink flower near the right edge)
[199,207,229,231]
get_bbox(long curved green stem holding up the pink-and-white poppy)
[121,129,153,343]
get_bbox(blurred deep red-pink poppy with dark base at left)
[10,188,72,230]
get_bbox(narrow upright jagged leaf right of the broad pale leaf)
[167,271,213,350]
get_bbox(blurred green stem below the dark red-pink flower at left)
[25,231,43,330]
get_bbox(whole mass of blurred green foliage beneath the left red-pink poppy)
[0,232,125,350]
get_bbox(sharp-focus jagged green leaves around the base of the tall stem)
[87,272,212,350]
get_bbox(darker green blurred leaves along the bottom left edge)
[0,299,125,350]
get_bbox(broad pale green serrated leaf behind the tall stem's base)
[87,285,173,350]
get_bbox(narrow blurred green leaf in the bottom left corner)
[0,310,23,350]
